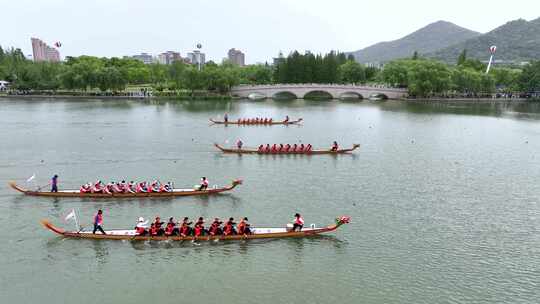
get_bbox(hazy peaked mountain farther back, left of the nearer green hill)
[349,21,480,63]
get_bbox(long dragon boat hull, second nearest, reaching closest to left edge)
[9,179,242,198]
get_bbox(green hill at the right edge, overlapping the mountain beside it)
[427,18,540,63]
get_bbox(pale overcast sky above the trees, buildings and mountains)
[0,0,540,63]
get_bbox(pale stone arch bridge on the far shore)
[231,84,407,99]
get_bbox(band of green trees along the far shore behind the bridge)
[0,47,540,99]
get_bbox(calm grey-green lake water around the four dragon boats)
[0,99,540,304]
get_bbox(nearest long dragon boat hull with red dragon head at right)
[41,216,350,241]
